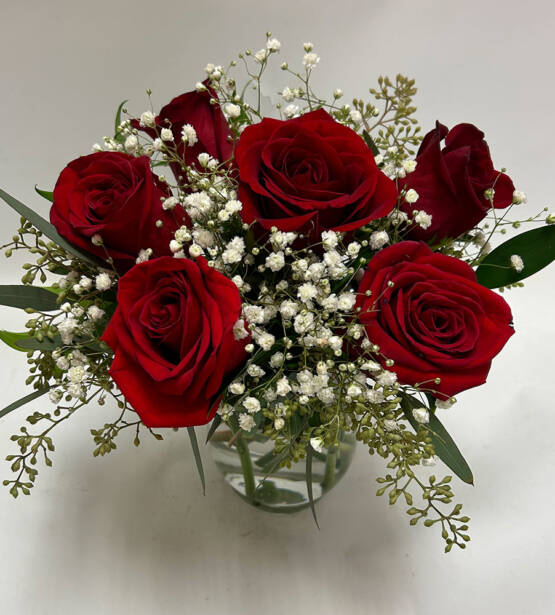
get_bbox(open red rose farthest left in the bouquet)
[50,152,188,271]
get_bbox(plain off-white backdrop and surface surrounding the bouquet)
[0,0,555,615]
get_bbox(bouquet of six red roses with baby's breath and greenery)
[0,33,555,551]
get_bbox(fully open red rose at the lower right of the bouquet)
[356,241,514,398]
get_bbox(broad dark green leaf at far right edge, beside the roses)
[476,225,555,288]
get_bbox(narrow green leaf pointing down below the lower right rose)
[401,395,474,485]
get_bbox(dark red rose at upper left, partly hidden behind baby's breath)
[133,81,233,178]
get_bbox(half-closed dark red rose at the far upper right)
[402,122,515,241]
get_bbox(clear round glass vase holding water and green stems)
[210,425,356,513]
